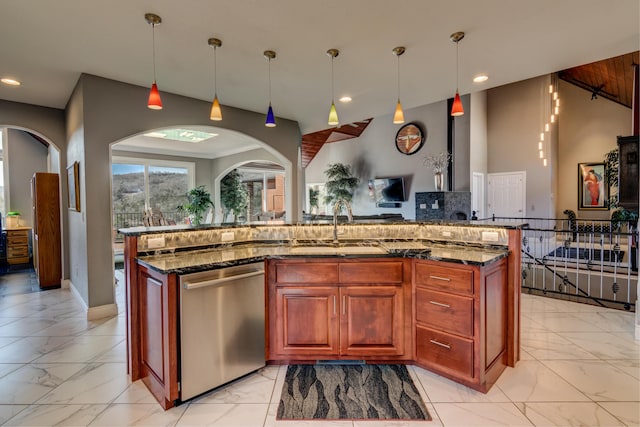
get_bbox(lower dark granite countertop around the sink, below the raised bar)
[138,241,509,274]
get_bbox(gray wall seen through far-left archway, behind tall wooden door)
[2,129,49,227]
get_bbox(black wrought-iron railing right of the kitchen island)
[484,217,638,311]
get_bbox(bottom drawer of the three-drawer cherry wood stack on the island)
[416,326,473,378]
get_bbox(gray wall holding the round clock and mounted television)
[305,96,469,219]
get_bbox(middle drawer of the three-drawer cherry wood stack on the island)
[416,288,473,337]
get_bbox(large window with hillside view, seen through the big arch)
[111,157,195,229]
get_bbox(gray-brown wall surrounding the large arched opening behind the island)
[67,74,301,307]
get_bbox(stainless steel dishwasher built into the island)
[180,262,265,401]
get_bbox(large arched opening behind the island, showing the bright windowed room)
[110,125,293,262]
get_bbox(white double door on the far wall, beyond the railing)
[487,171,527,218]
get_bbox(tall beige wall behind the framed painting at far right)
[556,81,631,219]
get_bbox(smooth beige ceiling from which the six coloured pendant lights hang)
[0,0,640,148]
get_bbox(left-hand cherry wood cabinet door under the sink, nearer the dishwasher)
[275,286,339,357]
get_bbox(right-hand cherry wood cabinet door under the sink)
[340,286,405,357]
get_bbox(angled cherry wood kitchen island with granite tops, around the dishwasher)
[121,222,520,408]
